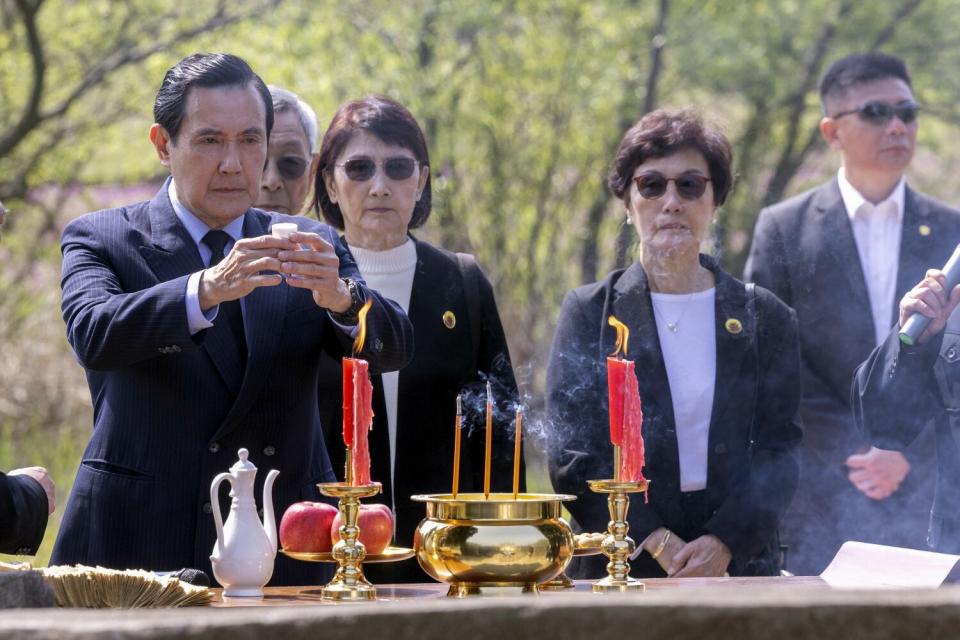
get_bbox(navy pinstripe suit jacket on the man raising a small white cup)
[52,184,413,584]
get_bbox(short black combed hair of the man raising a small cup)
[153,53,273,142]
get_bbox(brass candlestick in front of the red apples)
[318,482,381,602]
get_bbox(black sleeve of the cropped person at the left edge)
[0,472,49,556]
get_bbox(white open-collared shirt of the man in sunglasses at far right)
[837,167,906,345]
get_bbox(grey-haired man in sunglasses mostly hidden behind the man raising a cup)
[254,85,319,215]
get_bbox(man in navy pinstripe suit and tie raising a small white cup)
[52,54,413,584]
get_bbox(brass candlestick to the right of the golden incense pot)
[587,478,647,593]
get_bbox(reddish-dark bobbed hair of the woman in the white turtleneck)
[313,95,433,229]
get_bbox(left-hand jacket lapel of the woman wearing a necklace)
[616,262,680,482]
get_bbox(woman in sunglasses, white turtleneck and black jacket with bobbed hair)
[315,96,517,583]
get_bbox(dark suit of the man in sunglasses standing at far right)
[745,179,960,573]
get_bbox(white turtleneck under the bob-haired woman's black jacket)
[350,238,417,510]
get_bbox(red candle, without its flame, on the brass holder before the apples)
[343,358,373,486]
